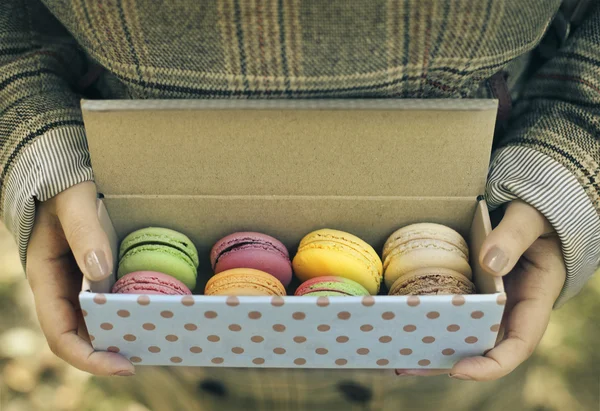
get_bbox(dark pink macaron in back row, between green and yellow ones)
[210,232,292,287]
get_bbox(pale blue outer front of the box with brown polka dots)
[80,201,506,368]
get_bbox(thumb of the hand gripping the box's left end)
[56,182,113,281]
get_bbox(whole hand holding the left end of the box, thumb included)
[27,182,135,376]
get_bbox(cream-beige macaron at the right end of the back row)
[383,223,473,288]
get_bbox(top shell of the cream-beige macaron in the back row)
[382,223,469,266]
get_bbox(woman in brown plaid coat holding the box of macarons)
[0,0,600,409]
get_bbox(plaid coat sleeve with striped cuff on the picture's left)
[0,0,93,265]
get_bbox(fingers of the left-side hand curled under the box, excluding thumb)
[27,225,135,375]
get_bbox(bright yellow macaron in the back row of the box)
[292,229,383,294]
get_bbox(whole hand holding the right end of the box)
[396,200,566,381]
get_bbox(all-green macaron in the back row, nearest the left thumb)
[117,227,199,289]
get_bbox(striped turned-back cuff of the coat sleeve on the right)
[486,146,600,308]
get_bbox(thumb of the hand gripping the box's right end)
[480,200,553,276]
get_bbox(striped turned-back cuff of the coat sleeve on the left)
[2,126,93,268]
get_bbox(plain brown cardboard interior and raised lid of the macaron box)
[82,100,503,294]
